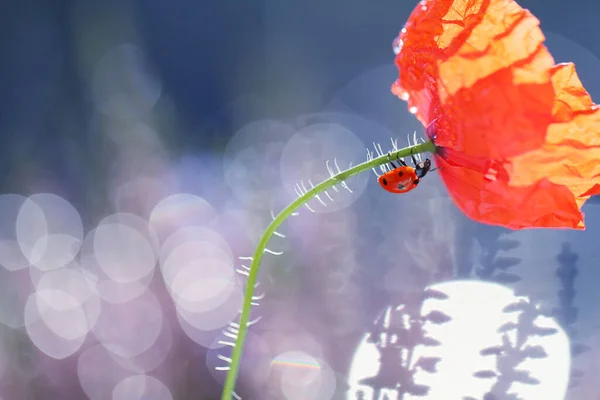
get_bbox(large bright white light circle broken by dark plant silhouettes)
[347,281,570,400]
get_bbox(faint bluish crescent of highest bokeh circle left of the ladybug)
[224,120,294,209]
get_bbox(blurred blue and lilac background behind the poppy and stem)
[0,0,600,400]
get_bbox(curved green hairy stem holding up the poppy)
[221,142,435,400]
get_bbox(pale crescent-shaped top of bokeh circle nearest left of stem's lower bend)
[150,193,216,241]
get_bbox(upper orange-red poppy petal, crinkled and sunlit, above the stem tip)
[392,0,554,159]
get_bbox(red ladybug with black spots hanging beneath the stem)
[377,153,431,193]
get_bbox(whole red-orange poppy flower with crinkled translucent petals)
[392,0,600,229]
